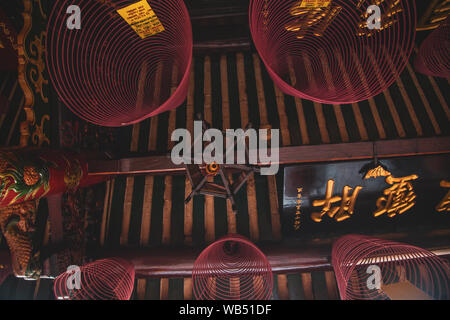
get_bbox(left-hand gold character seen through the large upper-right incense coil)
[285,1,342,39]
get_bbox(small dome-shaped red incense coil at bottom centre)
[192,235,273,300]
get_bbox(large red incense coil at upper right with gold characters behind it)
[249,0,416,104]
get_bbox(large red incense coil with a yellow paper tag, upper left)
[46,0,193,127]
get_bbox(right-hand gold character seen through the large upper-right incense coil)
[357,0,403,37]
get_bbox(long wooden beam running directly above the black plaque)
[89,137,450,175]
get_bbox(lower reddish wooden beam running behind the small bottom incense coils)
[99,230,450,278]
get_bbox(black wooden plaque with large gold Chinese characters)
[281,155,450,239]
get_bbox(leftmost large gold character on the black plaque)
[311,180,362,222]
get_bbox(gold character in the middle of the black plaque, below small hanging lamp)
[373,174,419,218]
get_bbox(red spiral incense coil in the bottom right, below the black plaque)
[332,235,450,300]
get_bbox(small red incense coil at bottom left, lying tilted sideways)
[53,258,135,300]
